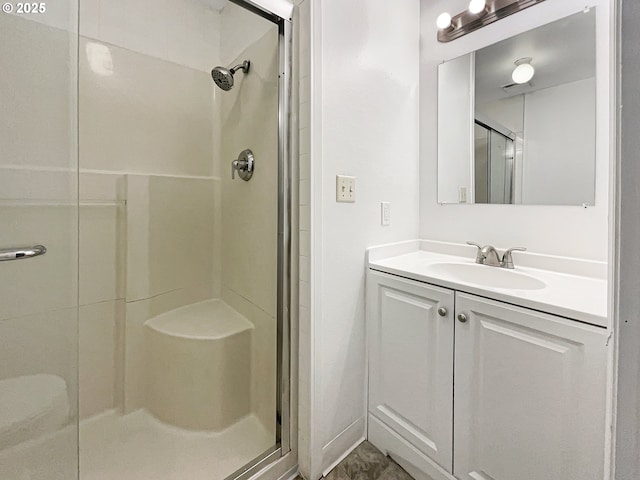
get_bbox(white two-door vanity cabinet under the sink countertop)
[367,267,607,480]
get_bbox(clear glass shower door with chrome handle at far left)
[0,1,78,480]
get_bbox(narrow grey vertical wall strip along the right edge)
[612,0,640,480]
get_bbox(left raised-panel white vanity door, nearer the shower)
[367,270,455,472]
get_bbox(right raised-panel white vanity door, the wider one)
[454,293,607,480]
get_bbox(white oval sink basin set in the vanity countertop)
[425,263,546,290]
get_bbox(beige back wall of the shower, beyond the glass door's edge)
[79,31,217,417]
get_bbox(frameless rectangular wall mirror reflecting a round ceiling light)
[438,8,596,205]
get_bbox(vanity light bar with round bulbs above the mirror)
[436,0,544,42]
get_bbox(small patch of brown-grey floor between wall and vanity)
[296,441,413,480]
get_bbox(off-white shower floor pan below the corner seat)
[80,410,275,480]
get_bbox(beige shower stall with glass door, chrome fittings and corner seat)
[0,0,296,480]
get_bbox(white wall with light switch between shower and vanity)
[308,0,419,480]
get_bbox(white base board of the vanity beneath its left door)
[368,414,456,480]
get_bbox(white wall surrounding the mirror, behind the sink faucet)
[420,0,611,260]
